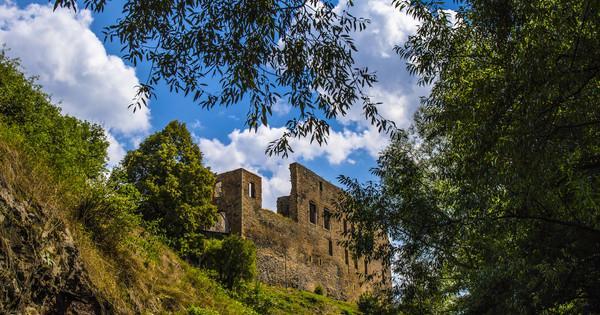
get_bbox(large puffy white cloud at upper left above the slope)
[0,3,150,164]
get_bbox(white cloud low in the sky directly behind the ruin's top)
[196,126,385,210]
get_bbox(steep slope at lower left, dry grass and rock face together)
[0,141,356,314]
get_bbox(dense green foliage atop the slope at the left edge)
[0,51,108,182]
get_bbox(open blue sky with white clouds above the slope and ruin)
[0,0,450,209]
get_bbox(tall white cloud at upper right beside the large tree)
[337,0,429,135]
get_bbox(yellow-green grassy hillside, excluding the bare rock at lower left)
[0,132,357,314]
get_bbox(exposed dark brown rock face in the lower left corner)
[0,186,110,314]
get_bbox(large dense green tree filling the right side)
[342,0,600,314]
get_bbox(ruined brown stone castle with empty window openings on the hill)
[215,163,391,300]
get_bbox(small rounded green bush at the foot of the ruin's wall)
[201,235,256,290]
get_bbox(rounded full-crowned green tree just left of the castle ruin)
[114,121,217,254]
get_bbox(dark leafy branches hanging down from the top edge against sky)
[55,0,392,155]
